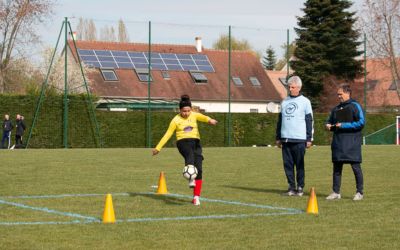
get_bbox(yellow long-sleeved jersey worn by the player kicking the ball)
[156,111,211,151]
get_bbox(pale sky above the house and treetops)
[39,0,363,57]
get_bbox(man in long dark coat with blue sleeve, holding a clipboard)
[326,84,365,201]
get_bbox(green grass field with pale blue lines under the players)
[0,146,400,249]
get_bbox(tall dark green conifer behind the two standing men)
[291,0,362,103]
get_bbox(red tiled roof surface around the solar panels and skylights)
[70,41,282,102]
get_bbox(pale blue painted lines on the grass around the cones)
[0,192,304,226]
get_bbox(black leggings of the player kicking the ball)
[176,138,204,180]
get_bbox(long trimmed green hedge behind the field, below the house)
[0,95,396,148]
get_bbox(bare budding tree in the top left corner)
[0,0,53,93]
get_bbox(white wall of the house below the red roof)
[192,100,280,113]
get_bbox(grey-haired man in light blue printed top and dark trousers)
[276,76,313,196]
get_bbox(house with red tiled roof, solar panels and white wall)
[69,38,282,113]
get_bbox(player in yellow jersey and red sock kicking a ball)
[153,95,217,206]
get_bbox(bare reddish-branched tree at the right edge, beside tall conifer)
[360,0,400,97]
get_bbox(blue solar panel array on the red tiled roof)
[78,49,215,72]
